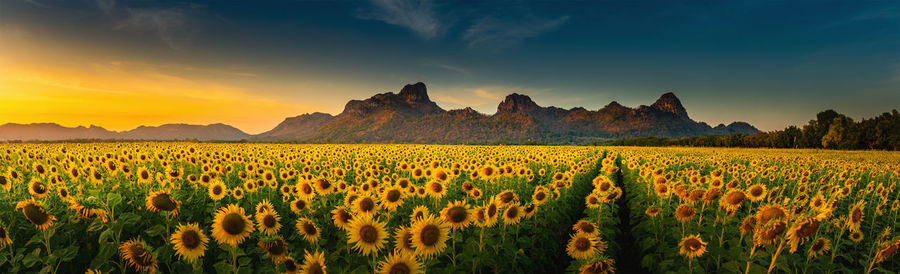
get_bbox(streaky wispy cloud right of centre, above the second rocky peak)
[463,15,569,48]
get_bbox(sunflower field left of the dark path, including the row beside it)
[0,143,621,273]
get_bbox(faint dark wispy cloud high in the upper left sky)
[116,9,191,50]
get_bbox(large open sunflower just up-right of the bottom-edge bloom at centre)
[409,216,450,259]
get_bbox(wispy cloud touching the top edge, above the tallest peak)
[359,0,442,39]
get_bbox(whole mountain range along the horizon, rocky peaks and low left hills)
[0,83,758,143]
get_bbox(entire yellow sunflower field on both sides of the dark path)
[0,142,900,273]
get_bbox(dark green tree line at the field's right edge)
[605,109,900,150]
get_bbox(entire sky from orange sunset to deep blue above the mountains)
[0,0,900,134]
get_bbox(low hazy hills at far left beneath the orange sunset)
[0,123,250,141]
